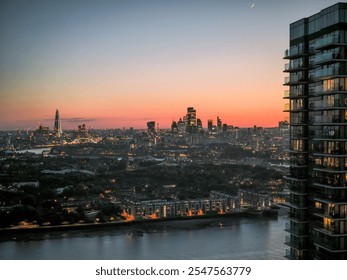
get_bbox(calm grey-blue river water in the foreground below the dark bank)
[0,212,288,260]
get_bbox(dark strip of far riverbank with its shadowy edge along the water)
[0,212,277,242]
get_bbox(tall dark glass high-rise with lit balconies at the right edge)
[284,3,347,259]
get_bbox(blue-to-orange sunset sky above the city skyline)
[0,0,337,130]
